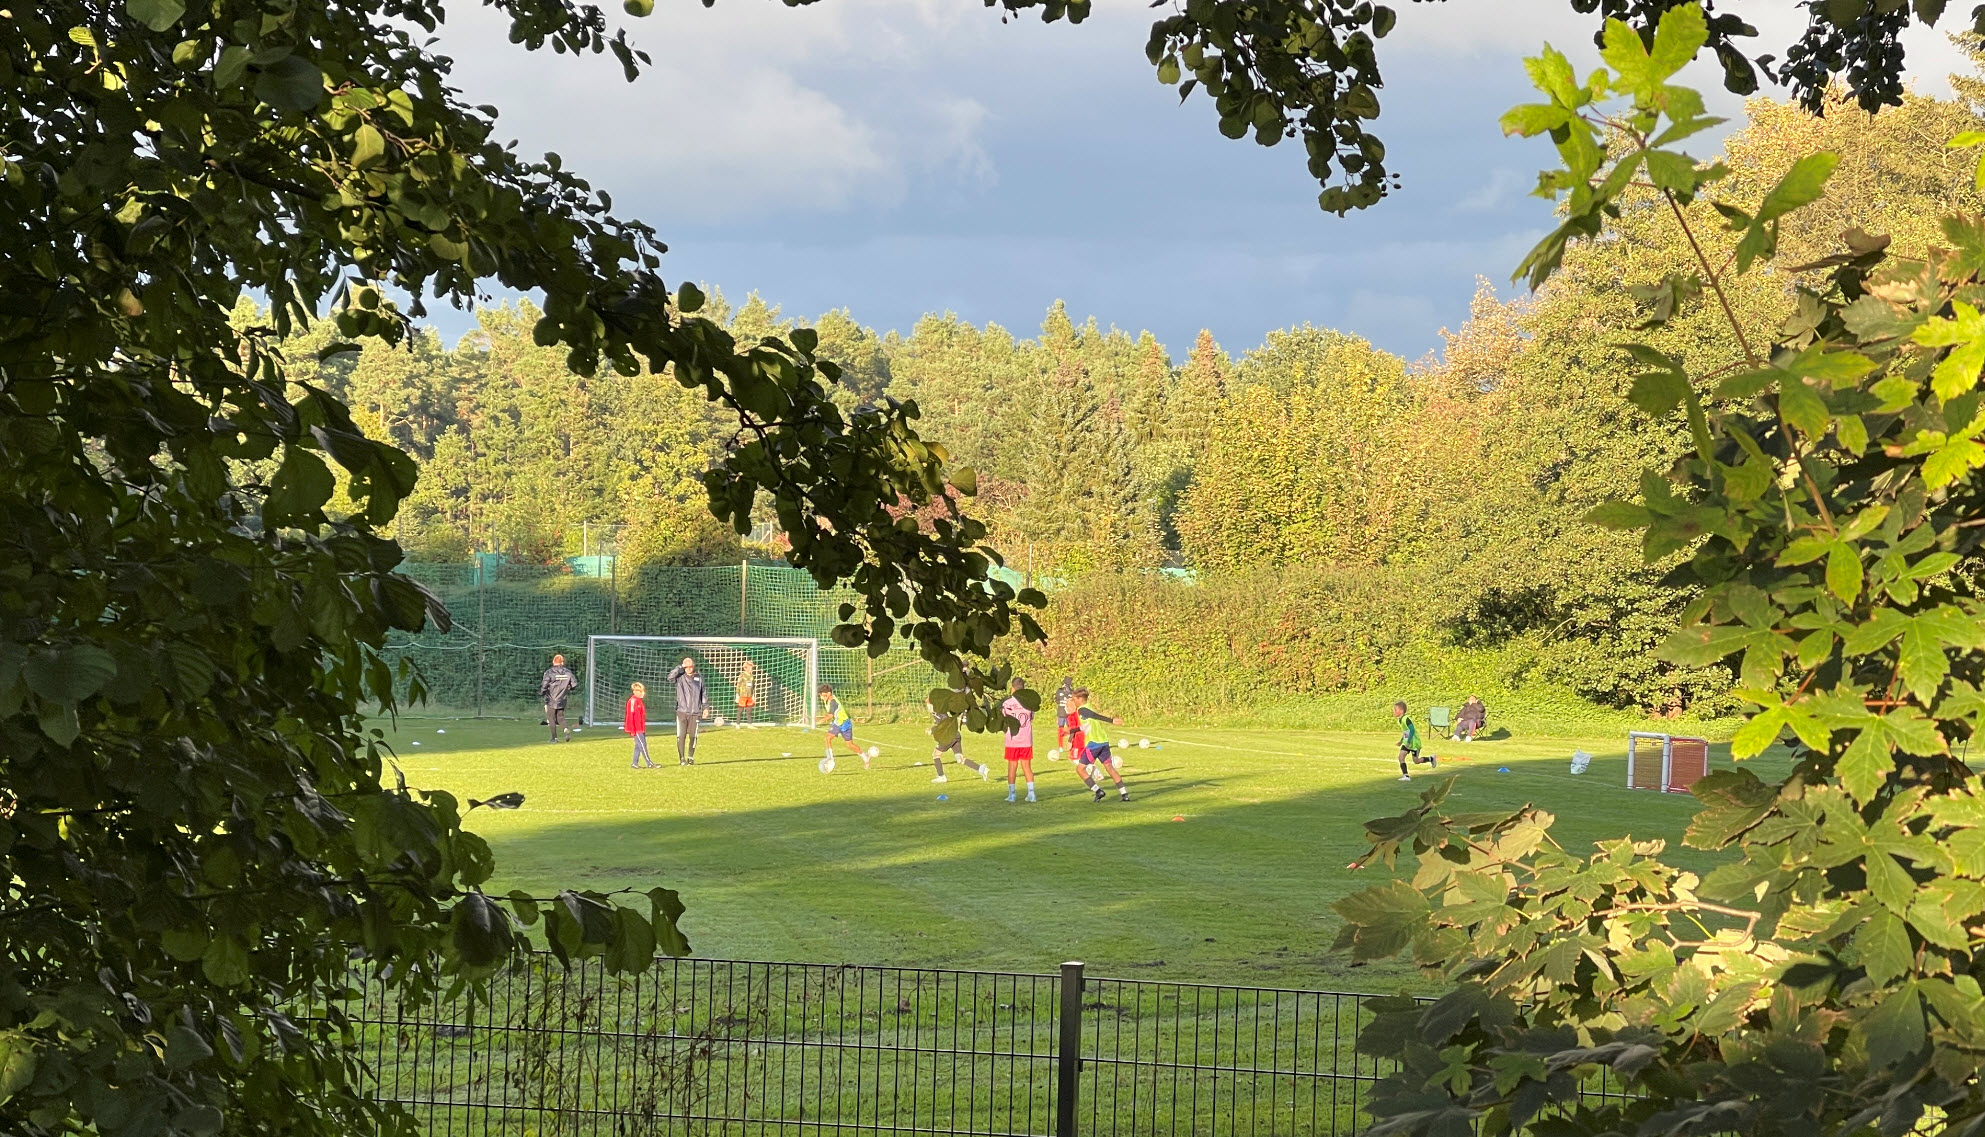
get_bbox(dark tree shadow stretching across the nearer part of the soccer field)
[472,730,1783,990]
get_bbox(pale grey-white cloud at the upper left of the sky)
[441,0,994,222]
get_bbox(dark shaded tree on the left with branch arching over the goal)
[0,0,1040,1137]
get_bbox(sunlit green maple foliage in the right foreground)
[1338,8,1985,1135]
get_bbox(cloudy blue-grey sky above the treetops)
[435,0,1959,359]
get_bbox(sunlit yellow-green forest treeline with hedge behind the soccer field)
[292,77,1985,714]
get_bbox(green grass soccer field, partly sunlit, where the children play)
[379,716,1787,990]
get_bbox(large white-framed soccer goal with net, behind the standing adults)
[586,635,820,730]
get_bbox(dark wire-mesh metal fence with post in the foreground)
[347,958,1429,1137]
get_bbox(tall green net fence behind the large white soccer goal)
[387,558,939,714]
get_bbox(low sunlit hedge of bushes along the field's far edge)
[1012,566,1729,730]
